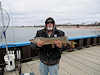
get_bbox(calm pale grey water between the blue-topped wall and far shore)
[0,27,100,43]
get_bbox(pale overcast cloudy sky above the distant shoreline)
[1,0,100,26]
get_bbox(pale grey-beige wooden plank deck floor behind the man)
[4,46,100,75]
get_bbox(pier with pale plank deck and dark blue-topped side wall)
[0,28,100,75]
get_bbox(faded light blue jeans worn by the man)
[40,62,59,75]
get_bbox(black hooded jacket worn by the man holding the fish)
[33,17,65,65]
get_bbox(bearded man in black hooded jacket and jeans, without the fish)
[36,17,65,75]
